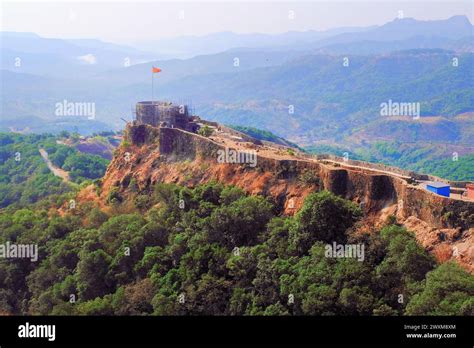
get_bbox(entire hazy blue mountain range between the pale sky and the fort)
[0,16,474,145]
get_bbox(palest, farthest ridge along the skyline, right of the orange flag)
[136,16,473,58]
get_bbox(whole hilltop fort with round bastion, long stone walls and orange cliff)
[88,102,474,274]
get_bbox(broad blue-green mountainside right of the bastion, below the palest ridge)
[155,50,474,143]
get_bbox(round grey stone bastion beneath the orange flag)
[136,101,199,133]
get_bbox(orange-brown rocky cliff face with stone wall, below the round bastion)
[97,125,474,272]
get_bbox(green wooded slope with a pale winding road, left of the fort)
[0,133,108,208]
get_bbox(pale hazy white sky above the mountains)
[1,0,473,42]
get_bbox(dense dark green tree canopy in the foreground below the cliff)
[0,183,474,315]
